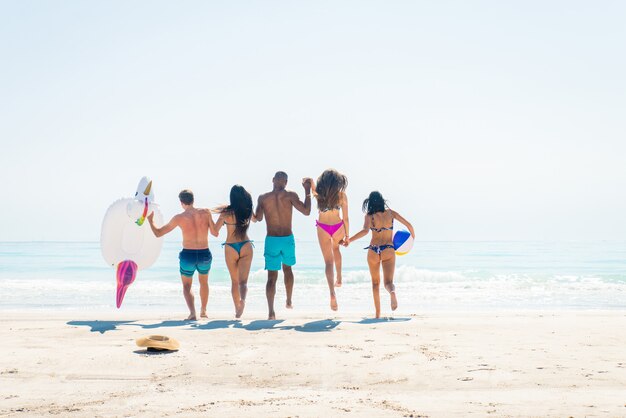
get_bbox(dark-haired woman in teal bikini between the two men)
[214,184,253,318]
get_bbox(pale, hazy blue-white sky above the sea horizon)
[0,0,626,240]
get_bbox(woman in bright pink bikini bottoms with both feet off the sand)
[313,169,350,311]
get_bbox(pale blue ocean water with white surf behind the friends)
[0,241,626,315]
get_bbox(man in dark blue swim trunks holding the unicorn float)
[148,190,215,321]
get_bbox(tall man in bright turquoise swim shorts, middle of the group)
[255,171,313,319]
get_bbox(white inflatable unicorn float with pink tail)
[100,177,163,308]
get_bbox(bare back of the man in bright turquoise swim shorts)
[259,190,299,237]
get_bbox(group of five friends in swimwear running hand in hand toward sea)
[148,169,415,320]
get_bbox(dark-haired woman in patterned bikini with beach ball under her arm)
[344,191,415,318]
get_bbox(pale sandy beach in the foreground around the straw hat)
[0,311,626,417]
